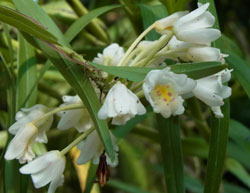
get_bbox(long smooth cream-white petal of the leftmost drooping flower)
[4,124,38,160]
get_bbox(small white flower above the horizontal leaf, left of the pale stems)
[93,43,124,66]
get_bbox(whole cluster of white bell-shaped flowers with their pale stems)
[5,3,232,193]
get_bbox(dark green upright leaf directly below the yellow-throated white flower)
[156,114,185,193]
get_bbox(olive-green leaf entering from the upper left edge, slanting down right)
[0,6,56,43]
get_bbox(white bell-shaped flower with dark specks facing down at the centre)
[98,82,146,125]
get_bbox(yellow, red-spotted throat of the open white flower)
[151,84,176,104]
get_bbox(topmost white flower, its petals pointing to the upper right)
[173,3,221,45]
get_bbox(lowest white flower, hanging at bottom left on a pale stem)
[20,150,66,193]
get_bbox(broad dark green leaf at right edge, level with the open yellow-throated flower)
[226,52,250,97]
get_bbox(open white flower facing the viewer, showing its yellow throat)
[143,67,196,118]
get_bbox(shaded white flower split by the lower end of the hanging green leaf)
[77,130,119,167]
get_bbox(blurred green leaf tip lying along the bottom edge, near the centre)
[107,179,150,193]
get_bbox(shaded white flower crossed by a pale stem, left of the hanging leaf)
[57,95,93,132]
